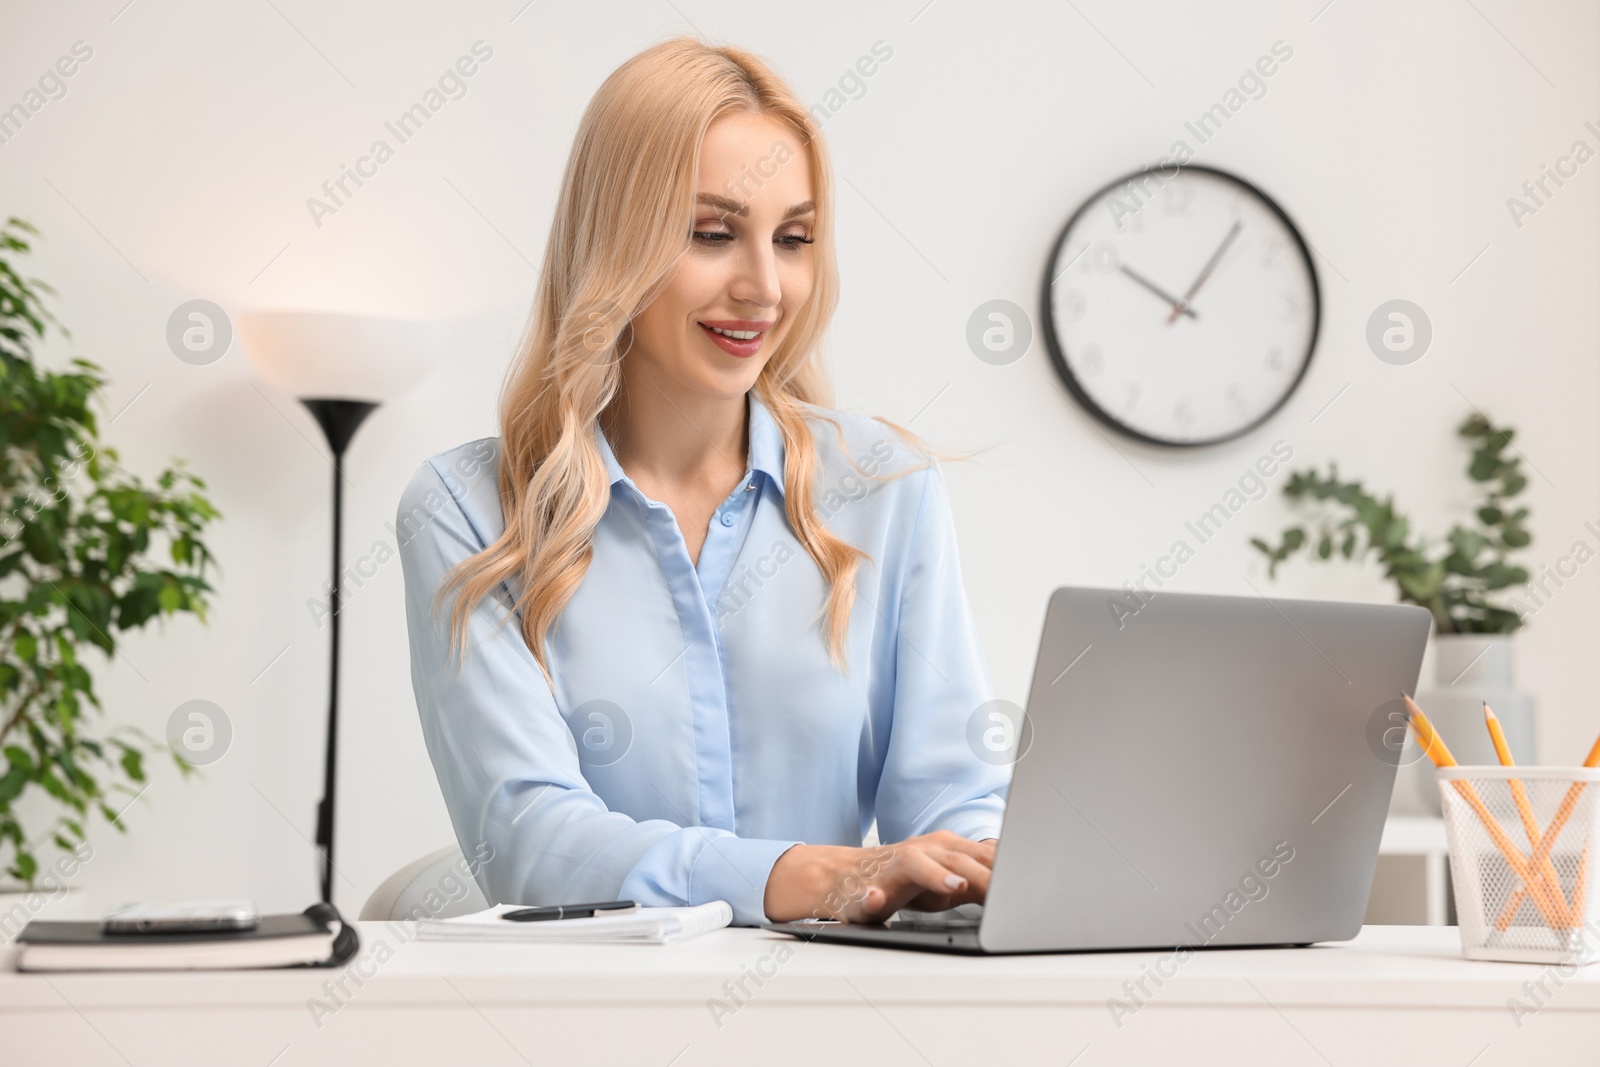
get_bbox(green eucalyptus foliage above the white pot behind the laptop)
[1250,413,1533,633]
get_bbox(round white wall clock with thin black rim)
[1043,166,1320,445]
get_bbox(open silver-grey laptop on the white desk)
[766,589,1432,953]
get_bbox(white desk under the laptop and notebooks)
[0,923,1600,1067]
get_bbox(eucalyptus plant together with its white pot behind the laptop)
[1251,413,1536,814]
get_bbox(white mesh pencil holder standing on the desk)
[1437,766,1600,963]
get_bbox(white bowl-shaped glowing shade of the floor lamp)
[237,310,445,403]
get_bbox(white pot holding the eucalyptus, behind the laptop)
[1389,633,1538,817]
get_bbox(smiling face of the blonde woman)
[622,112,816,398]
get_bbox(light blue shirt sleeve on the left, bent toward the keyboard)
[395,462,797,925]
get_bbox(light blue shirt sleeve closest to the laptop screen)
[877,466,1011,841]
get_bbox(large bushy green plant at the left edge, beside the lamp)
[0,218,219,886]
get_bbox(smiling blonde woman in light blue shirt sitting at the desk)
[398,38,1008,925]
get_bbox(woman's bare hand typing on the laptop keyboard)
[763,830,995,923]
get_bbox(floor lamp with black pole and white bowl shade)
[238,310,443,902]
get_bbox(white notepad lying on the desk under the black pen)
[416,901,733,945]
